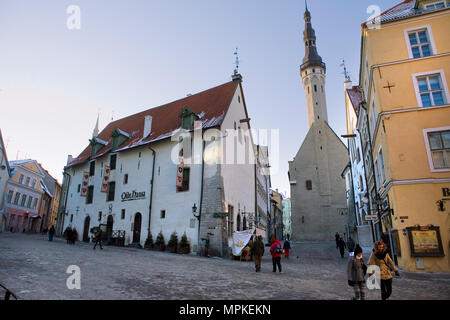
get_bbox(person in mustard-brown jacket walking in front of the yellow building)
[367,241,400,300]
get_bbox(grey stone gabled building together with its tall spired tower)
[289,3,349,241]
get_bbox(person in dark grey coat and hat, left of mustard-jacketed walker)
[347,245,367,300]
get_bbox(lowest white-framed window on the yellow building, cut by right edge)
[425,128,450,170]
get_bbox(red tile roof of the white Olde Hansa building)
[67,81,239,167]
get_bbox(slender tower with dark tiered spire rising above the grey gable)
[300,1,328,128]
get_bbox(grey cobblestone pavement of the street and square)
[0,233,450,300]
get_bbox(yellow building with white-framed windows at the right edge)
[359,0,450,272]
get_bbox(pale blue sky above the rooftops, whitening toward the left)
[0,0,401,196]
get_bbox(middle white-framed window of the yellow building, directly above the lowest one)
[417,74,446,107]
